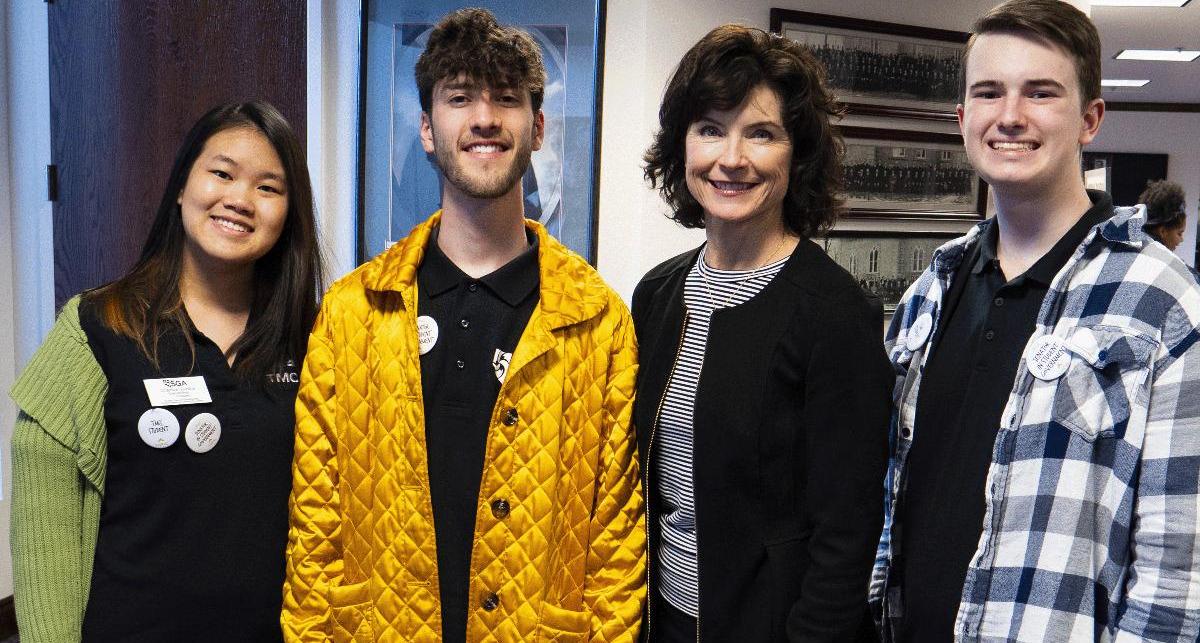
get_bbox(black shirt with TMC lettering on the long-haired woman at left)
[79,299,300,643]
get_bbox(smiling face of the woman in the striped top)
[684,85,792,228]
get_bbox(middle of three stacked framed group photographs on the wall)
[840,127,988,220]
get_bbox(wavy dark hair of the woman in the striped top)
[643,24,845,238]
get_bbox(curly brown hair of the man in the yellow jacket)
[415,8,546,114]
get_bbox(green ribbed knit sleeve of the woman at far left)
[11,298,108,643]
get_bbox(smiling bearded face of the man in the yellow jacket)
[421,77,545,199]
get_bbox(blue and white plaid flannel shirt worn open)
[870,206,1200,643]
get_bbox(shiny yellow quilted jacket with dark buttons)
[282,214,646,642]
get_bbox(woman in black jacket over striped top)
[632,25,892,642]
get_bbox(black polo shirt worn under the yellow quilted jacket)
[416,225,539,643]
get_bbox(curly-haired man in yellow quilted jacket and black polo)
[282,10,646,642]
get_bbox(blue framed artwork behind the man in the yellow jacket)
[358,0,605,263]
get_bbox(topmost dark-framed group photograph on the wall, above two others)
[770,8,971,121]
